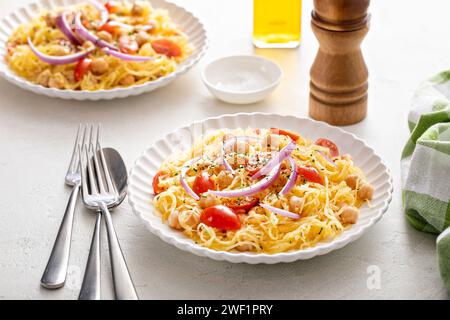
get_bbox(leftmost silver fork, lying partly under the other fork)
[41,125,83,289]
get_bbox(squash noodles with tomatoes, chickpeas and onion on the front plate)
[153,128,373,254]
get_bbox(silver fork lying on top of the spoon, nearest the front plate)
[79,126,138,300]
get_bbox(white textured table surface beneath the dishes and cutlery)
[0,0,450,299]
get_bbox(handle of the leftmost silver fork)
[41,182,81,289]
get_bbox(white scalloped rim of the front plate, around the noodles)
[128,113,393,264]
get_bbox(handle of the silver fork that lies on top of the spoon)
[100,203,139,300]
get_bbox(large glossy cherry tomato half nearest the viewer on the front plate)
[200,205,241,230]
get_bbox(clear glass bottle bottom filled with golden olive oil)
[253,0,302,48]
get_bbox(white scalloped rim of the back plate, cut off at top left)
[0,0,208,100]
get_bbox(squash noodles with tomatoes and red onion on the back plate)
[6,1,193,91]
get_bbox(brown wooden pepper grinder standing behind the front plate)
[309,0,370,125]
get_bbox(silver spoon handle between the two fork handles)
[78,213,102,300]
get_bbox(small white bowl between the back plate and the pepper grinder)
[202,55,283,104]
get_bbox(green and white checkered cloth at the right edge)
[401,71,450,290]
